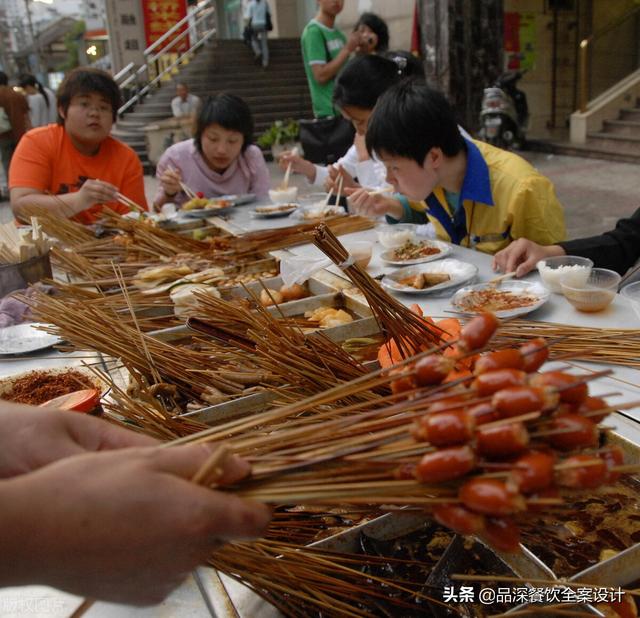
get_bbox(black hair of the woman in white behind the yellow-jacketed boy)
[333,54,424,109]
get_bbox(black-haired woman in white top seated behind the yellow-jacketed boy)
[279,52,424,190]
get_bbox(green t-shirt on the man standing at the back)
[300,19,347,118]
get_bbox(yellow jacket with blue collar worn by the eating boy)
[390,139,566,253]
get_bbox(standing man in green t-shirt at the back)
[301,0,361,118]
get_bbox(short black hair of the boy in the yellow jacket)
[366,79,465,165]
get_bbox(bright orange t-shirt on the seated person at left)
[9,124,148,224]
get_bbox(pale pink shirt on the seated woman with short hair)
[156,139,271,204]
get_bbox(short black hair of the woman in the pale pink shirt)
[193,92,253,153]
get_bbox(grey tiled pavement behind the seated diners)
[0,152,640,238]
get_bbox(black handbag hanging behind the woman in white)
[300,116,355,165]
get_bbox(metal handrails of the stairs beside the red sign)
[114,0,216,114]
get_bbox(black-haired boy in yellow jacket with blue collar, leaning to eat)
[349,81,565,253]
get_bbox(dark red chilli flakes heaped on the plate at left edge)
[0,369,97,406]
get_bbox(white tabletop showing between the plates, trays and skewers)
[5,199,640,618]
